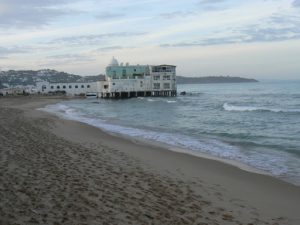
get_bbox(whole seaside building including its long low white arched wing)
[37,58,177,98]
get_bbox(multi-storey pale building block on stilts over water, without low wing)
[100,58,177,98]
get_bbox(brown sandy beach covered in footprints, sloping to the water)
[0,96,300,225]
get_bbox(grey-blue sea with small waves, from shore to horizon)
[44,81,300,185]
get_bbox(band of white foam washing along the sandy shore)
[42,104,288,180]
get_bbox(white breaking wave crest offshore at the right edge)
[223,103,300,113]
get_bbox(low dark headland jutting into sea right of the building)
[177,76,258,84]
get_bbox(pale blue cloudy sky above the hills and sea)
[0,0,300,79]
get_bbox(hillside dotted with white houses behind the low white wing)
[0,69,104,88]
